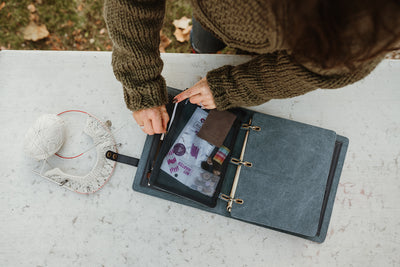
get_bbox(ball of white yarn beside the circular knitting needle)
[24,114,65,160]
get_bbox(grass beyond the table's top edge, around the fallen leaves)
[0,0,192,53]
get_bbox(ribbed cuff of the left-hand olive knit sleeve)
[123,77,168,111]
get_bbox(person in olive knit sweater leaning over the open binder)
[104,0,400,135]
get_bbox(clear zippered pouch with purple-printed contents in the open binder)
[149,101,247,207]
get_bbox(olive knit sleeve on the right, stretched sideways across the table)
[207,51,381,110]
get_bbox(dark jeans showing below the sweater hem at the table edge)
[190,17,226,54]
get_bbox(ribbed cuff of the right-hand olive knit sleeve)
[207,65,236,110]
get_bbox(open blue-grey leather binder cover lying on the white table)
[133,88,348,242]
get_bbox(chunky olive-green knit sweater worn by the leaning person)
[104,0,381,111]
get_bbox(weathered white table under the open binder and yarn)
[0,51,400,266]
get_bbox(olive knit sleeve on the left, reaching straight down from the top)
[104,0,167,111]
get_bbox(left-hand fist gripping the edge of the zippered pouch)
[133,105,169,135]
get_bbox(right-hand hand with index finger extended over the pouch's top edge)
[174,77,216,109]
